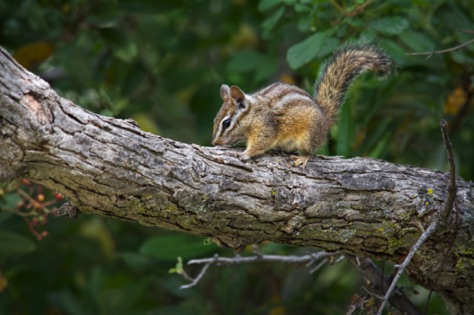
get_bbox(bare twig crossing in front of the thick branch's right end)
[377,120,457,315]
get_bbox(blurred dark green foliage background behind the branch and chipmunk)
[0,0,474,315]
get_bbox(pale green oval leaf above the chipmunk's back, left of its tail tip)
[286,31,339,69]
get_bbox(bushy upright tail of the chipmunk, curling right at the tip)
[314,45,394,126]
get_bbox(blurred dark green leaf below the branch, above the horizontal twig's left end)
[139,235,216,262]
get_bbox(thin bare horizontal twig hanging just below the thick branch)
[180,252,343,289]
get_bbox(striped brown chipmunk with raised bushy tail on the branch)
[212,45,393,167]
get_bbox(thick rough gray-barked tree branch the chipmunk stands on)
[0,49,474,314]
